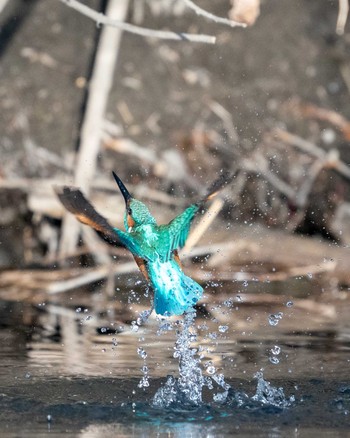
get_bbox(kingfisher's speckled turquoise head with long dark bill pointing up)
[113,172,156,231]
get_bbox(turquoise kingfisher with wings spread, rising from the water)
[56,172,233,316]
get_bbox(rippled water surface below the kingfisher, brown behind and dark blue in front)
[0,284,350,437]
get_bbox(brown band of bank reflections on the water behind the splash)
[0,286,350,379]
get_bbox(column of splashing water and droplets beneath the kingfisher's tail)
[152,310,295,410]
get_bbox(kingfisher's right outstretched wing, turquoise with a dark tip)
[161,172,236,260]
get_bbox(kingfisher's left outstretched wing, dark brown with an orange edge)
[55,186,134,251]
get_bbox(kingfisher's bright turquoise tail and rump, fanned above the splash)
[149,261,203,316]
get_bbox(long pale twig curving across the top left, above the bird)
[59,0,216,44]
